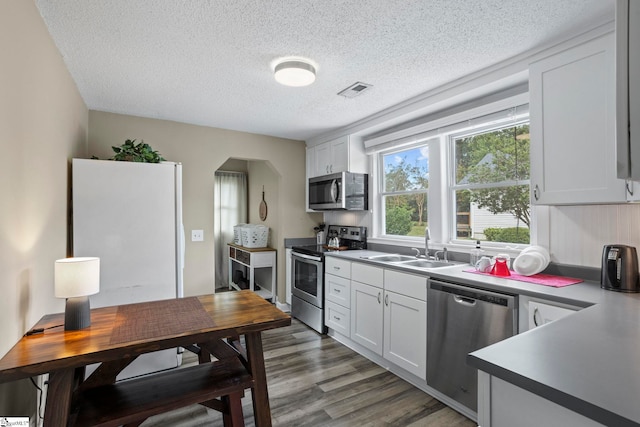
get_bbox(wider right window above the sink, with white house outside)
[449,122,531,244]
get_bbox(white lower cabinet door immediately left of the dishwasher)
[383,291,427,380]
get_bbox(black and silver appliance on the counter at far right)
[600,245,640,292]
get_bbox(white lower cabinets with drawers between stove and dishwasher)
[325,257,427,381]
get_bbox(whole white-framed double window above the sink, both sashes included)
[365,98,531,247]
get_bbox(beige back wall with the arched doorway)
[89,111,321,302]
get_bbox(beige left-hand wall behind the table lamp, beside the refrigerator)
[0,0,88,416]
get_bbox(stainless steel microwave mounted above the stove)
[309,172,369,211]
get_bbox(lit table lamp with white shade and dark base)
[55,257,100,331]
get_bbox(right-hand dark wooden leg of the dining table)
[245,332,271,427]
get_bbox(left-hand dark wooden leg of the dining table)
[43,368,76,427]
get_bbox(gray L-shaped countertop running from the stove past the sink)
[327,251,640,426]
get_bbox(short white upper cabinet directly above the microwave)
[307,135,367,178]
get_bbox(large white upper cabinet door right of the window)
[529,34,626,205]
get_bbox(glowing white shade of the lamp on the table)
[55,257,100,298]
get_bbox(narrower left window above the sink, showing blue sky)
[380,144,429,236]
